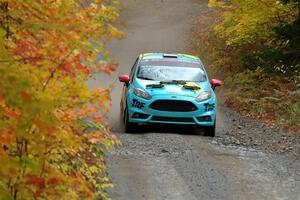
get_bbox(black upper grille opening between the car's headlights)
[150,100,197,112]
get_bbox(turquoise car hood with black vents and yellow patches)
[136,79,211,98]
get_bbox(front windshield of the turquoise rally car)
[137,60,207,82]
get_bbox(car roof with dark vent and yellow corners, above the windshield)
[141,53,201,63]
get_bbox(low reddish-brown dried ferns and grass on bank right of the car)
[224,71,300,132]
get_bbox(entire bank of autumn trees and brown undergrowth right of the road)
[193,0,300,131]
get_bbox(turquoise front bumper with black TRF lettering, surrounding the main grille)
[127,95,216,126]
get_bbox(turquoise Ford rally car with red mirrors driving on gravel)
[119,53,221,137]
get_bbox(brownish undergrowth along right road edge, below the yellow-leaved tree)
[191,11,300,133]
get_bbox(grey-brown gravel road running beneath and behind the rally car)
[89,0,300,200]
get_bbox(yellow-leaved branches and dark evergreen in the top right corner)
[209,0,300,76]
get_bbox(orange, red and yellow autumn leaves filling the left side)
[0,0,122,199]
